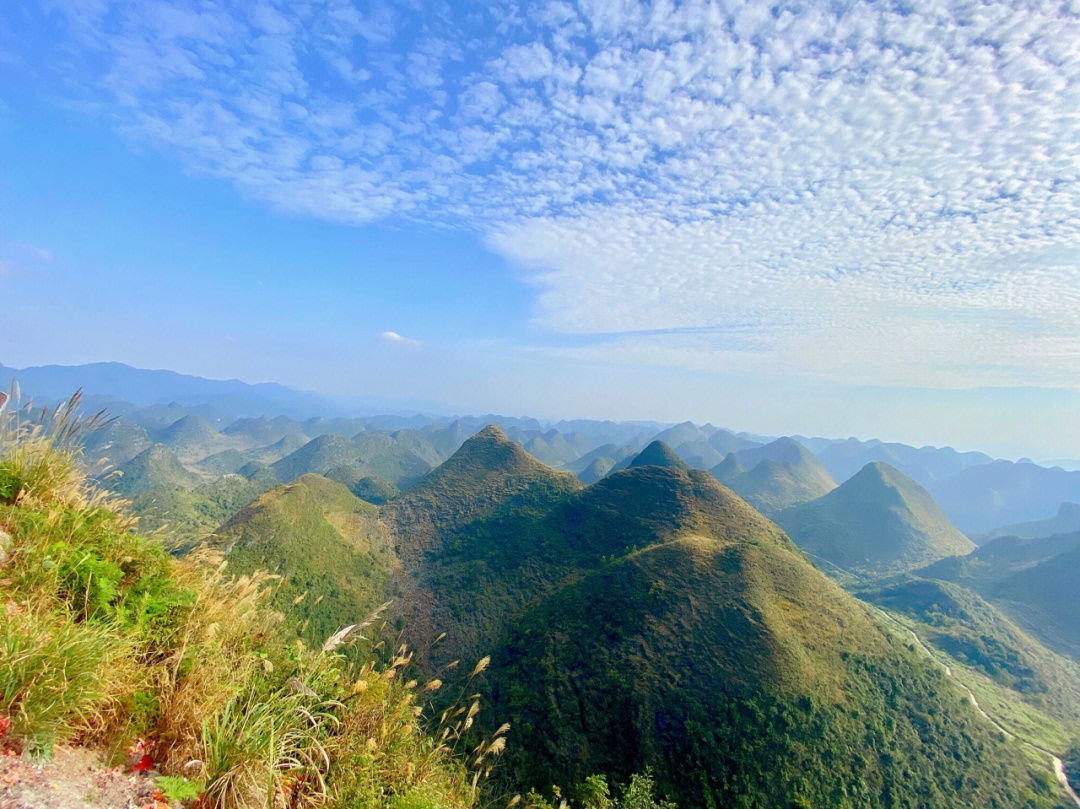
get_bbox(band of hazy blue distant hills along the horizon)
[8,363,1080,535]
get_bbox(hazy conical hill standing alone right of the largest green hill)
[777,462,975,576]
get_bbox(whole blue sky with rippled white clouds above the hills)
[0,0,1080,458]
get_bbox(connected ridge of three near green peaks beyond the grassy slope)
[172,427,1057,809]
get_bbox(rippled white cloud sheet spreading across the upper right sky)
[8,0,1080,387]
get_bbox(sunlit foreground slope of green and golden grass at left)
[0,402,494,809]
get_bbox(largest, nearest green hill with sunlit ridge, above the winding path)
[475,467,1053,808]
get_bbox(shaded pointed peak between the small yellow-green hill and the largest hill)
[383,426,581,662]
